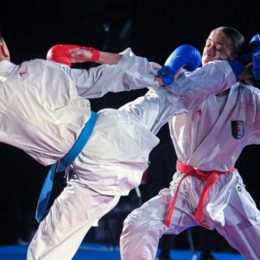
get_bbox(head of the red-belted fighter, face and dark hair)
[202,26,246,65]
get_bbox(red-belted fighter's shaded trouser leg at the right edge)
[216,176,260,259]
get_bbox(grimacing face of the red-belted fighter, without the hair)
[202,30,235,66]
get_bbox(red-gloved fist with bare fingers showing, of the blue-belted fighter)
[47,44,100,66]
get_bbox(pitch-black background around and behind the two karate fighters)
[0,0,260,252]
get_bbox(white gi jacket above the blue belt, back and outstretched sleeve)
[0,53,157,165]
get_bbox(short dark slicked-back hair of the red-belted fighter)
[213,26,247,57]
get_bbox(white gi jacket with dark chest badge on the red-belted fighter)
[169,84,260,228]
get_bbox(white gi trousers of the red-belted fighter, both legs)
[120,173,260,260]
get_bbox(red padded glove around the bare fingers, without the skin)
[47,44,100,66]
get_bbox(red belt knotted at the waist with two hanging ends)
[164,160,235,227]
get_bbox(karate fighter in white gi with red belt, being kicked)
[120,27,260,260]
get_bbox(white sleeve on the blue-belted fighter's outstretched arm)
[63,48,159,98]
